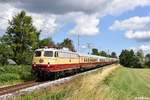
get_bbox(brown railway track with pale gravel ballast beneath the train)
[0,65,117,100]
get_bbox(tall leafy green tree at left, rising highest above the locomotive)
[5,11,40,64]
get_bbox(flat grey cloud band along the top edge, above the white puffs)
[3,0,150,15]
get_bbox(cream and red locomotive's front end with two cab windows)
[32,49,55,77]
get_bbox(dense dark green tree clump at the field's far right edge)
[119,50,150,68]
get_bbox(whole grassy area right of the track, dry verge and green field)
[17,65,150,100]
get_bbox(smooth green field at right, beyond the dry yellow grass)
[103,67,150,100]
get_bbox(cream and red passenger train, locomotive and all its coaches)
[32,48,118,79]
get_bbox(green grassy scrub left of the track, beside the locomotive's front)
[0,65,33,86]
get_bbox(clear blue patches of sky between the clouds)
[52,6,150,53]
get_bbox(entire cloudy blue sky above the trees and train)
[0,0,150,54]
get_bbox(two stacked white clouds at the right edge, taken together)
[109,16,150,41]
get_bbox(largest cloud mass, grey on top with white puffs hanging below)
[0,0,150,35]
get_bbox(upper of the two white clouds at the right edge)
[109,16,150,30]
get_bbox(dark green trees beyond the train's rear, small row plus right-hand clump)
[92,48,150,68]
